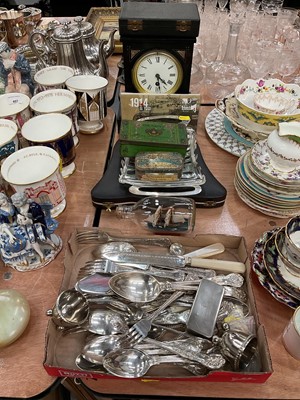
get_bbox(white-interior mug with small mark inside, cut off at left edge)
[0,93,32,147]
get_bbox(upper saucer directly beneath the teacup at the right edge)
[263,234,300,301]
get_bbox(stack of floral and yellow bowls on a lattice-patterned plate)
[205,79,300,157]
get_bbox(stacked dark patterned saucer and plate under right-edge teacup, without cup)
[251,228,300,308]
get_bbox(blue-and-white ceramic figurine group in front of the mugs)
[0,193,62,271]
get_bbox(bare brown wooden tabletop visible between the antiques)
[0,56,300,399]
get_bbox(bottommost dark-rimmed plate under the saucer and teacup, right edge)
[251,228,300,309]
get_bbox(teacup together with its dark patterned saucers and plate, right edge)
[251,216,300,309]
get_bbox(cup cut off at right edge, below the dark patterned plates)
[282,307,300,360]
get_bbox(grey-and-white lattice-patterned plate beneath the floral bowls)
[205,108,253,157]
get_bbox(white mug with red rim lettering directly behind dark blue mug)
[30,89,79,146]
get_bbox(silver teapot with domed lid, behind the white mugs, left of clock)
[29,21,114,77]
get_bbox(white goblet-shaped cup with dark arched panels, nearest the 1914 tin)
[66,75,108,134]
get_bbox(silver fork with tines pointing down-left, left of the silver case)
[127,291,184,343]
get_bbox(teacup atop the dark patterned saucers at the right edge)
[285,215,300,267]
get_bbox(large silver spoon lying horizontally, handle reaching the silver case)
[108,271,201,303]
